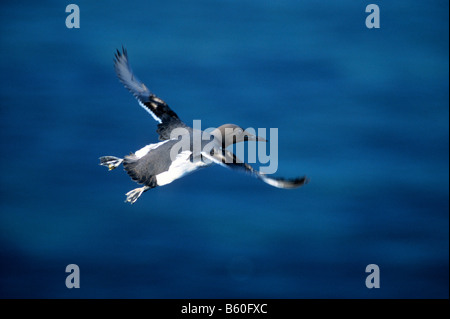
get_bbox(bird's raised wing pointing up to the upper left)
[114,47,187,140]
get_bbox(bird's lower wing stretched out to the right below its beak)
[202,148,309,188]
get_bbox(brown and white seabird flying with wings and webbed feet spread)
[99,46,309,204]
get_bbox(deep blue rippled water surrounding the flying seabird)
[0,0,449,298]
